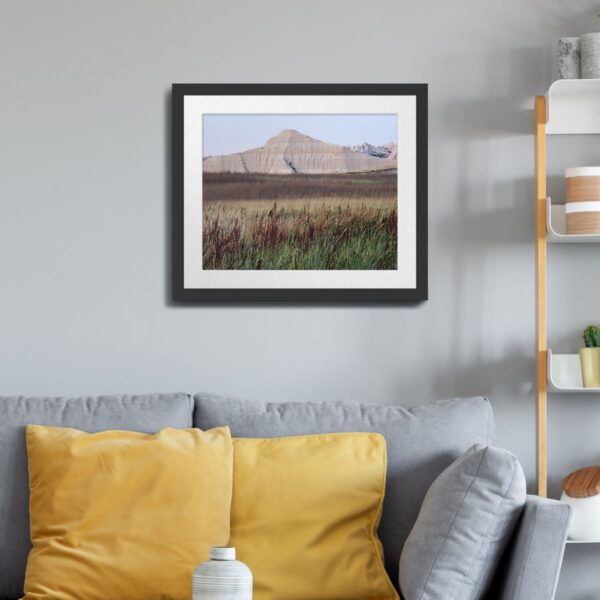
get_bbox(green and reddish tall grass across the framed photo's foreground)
[203,204,397,270]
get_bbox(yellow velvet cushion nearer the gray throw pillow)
[230,433,398,600]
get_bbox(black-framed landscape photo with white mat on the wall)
[172,84,427,303]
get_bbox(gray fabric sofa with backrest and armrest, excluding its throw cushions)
[0,394,570,600]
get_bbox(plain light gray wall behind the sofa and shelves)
[0,0,600,600]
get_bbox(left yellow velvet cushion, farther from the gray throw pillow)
[25,425,233,600]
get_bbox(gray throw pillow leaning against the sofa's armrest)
[400,445,526,600]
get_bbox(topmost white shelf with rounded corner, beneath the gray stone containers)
[546,79,600,135]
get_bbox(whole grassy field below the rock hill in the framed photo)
[202,172,398,270]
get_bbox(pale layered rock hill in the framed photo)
[203,129,397,175]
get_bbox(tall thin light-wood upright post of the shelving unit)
[535,96,548,497]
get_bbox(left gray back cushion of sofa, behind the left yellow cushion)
[0,394,193,598]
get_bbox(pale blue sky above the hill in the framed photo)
[202,114,398,156]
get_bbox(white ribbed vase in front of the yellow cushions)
[192,548,252,600]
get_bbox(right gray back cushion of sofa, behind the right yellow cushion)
[194,394,494,586]
